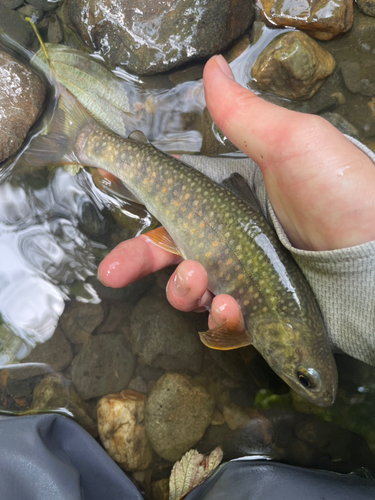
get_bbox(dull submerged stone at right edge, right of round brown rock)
[340,60,375,97]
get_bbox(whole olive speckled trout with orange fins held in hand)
[26,88,337,406]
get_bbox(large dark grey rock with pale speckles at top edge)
[62,0,254,75]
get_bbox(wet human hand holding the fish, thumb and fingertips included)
[98,56,375,328]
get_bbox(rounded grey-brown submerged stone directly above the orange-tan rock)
[72,334,134,399]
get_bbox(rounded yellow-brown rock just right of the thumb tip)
[253,32,335,99]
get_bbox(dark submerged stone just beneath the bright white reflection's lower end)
[22,327,73,373]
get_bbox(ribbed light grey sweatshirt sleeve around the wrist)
[182,136,375,366]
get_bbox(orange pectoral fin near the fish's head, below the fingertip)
[199,322,251,351]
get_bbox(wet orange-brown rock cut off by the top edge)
[257,0,353,40]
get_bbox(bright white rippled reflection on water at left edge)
[0,168,144,365]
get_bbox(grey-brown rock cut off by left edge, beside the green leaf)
[0,49,46,162]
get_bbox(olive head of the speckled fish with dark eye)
[254,319,338,406]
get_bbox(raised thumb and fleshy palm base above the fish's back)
[203,55,375,250]
